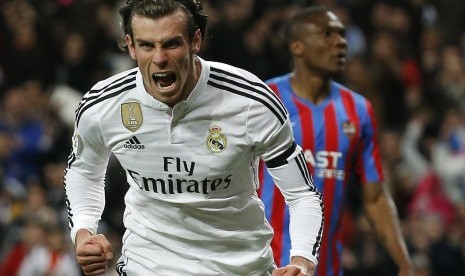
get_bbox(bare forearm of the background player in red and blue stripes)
[365,191,411,268]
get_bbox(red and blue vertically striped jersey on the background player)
[259,74,383,276]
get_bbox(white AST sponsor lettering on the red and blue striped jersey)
[304,149,345,180]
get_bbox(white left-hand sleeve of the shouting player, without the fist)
[64,102,111,242]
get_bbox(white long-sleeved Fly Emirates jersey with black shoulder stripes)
[65,58,322,275]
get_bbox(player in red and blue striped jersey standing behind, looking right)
[259,6,412,276]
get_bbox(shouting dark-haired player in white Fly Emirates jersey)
[65,0,323,276]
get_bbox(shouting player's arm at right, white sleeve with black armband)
[244,76,323,276]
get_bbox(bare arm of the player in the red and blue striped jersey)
[363,183,413,276]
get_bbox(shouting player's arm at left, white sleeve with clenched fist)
[64,116,113,276]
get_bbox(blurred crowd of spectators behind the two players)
[0,0,465,276]
